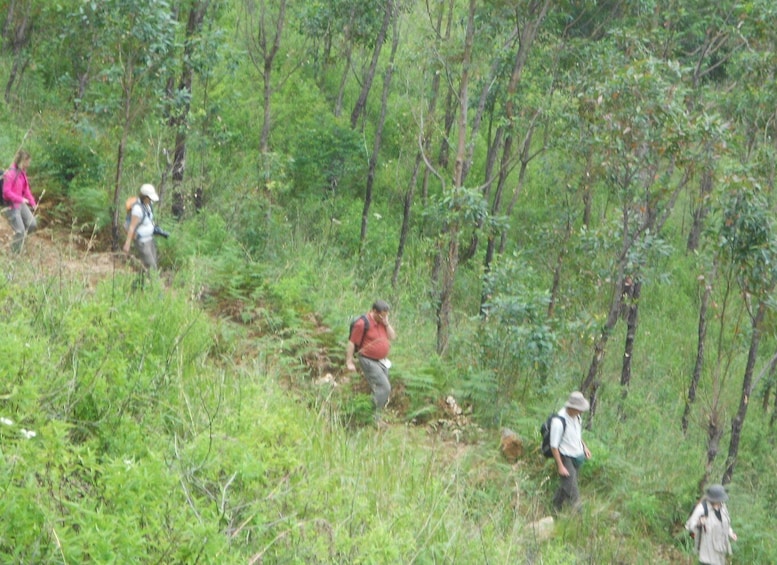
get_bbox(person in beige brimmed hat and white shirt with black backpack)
[550,391,591,511]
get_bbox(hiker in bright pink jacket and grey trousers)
[3,149,38,253]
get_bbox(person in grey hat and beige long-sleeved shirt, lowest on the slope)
[685,485,737,565]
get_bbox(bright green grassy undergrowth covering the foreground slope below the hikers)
[0,223,736,564]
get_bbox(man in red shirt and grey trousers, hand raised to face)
[345,300,397,421]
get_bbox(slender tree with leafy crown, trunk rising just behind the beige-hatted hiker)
[582,52,693,416]
